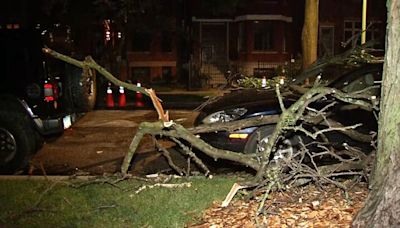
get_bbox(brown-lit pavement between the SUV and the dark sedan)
[31,110,197,175]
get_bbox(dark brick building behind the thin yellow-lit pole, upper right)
[318,0,386,57]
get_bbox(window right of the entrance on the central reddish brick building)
[253,21,274,51]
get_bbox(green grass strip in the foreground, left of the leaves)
[0,177,235,227]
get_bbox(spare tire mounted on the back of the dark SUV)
[64,64,97,112]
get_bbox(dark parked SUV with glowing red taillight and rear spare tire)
[0,29,95,173]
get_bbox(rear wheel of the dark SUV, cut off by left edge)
[0,111,39,174]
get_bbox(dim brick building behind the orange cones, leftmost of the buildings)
[115,0,178,85]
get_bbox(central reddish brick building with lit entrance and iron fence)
[192,0,303,86]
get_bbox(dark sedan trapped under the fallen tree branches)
[195,64,382,153]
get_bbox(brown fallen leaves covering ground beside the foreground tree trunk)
[188,184,367,228]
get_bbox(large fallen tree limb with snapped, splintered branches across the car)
[43,44,378,207]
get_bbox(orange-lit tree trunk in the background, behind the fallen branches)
[302,0,319,69]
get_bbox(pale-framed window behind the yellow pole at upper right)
[344,20,385,46]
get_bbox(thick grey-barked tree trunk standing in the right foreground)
[353,0,400,227]
